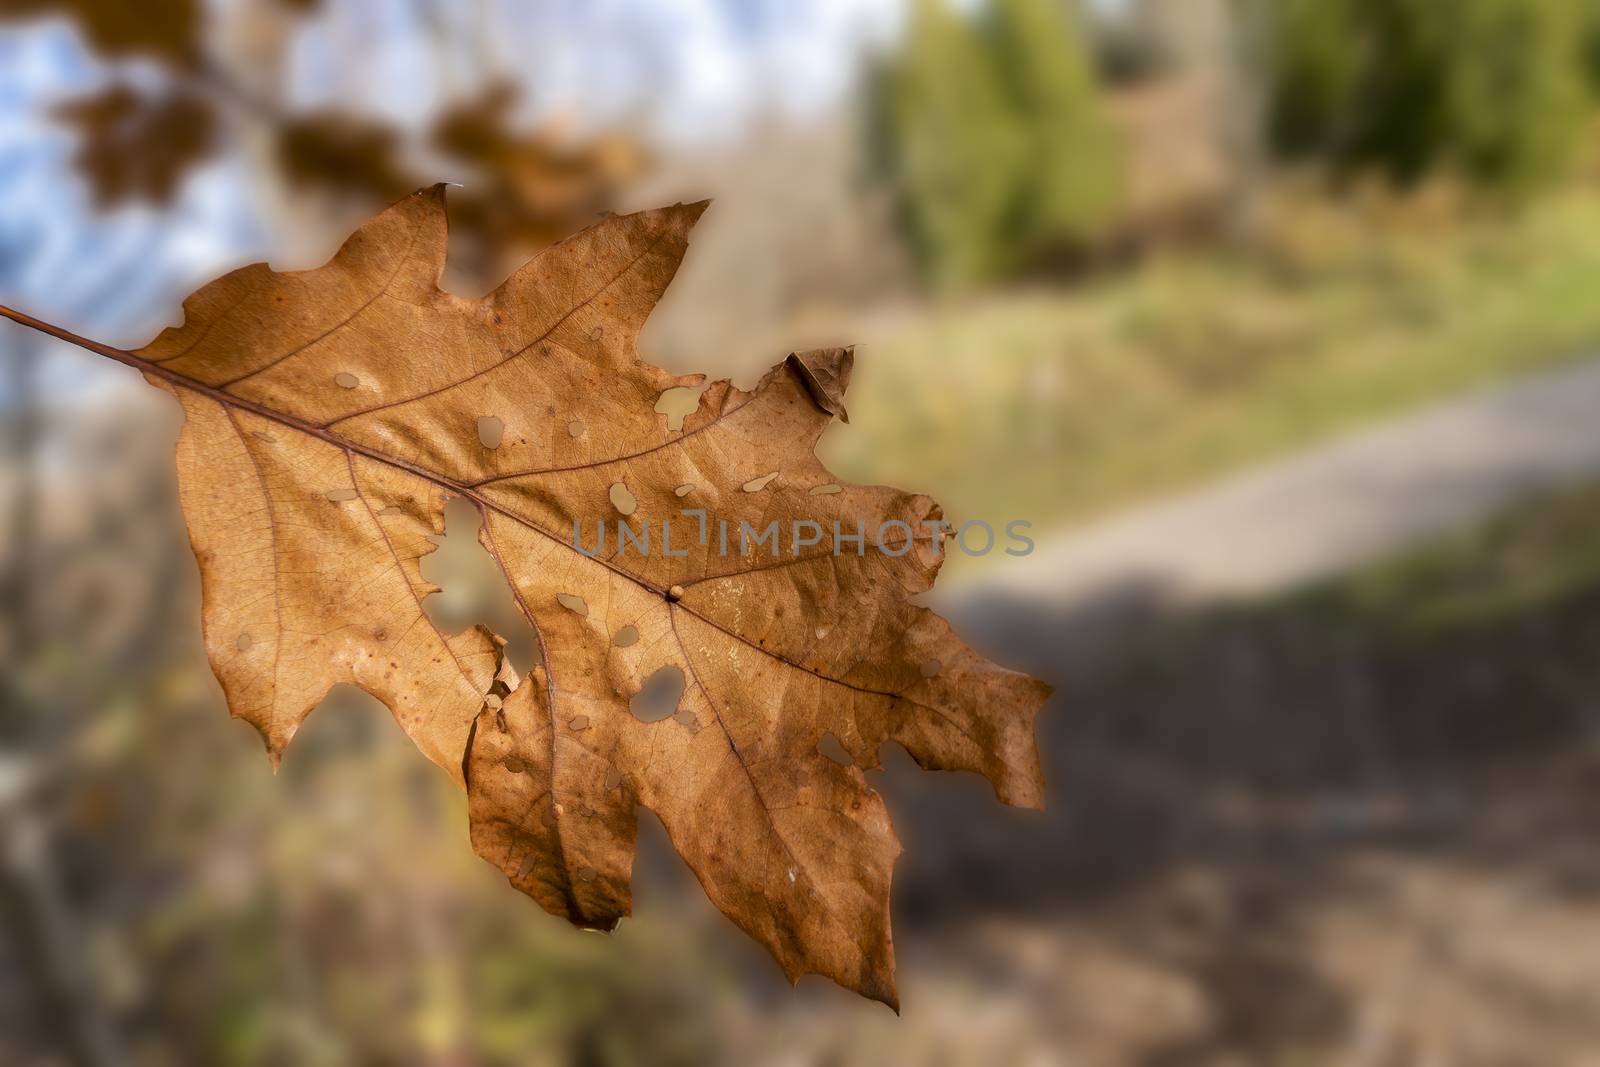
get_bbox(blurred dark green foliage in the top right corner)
[1253,0,1594,190]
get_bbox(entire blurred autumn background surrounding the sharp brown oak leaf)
[9,0,1600,1067]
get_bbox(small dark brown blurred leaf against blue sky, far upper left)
[56,85,216,208]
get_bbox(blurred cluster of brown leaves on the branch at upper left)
[0,0,643,271]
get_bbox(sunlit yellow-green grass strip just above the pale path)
[824,190,1600,526]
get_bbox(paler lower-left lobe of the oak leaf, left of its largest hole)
[165,390,501,779]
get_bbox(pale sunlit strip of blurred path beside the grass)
[941,360,1600,606]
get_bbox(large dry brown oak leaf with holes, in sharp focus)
[3,187,1048,1006]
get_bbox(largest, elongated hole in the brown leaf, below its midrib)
[422,498,539,675]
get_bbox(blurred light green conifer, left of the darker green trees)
[872,0,1117,288]
